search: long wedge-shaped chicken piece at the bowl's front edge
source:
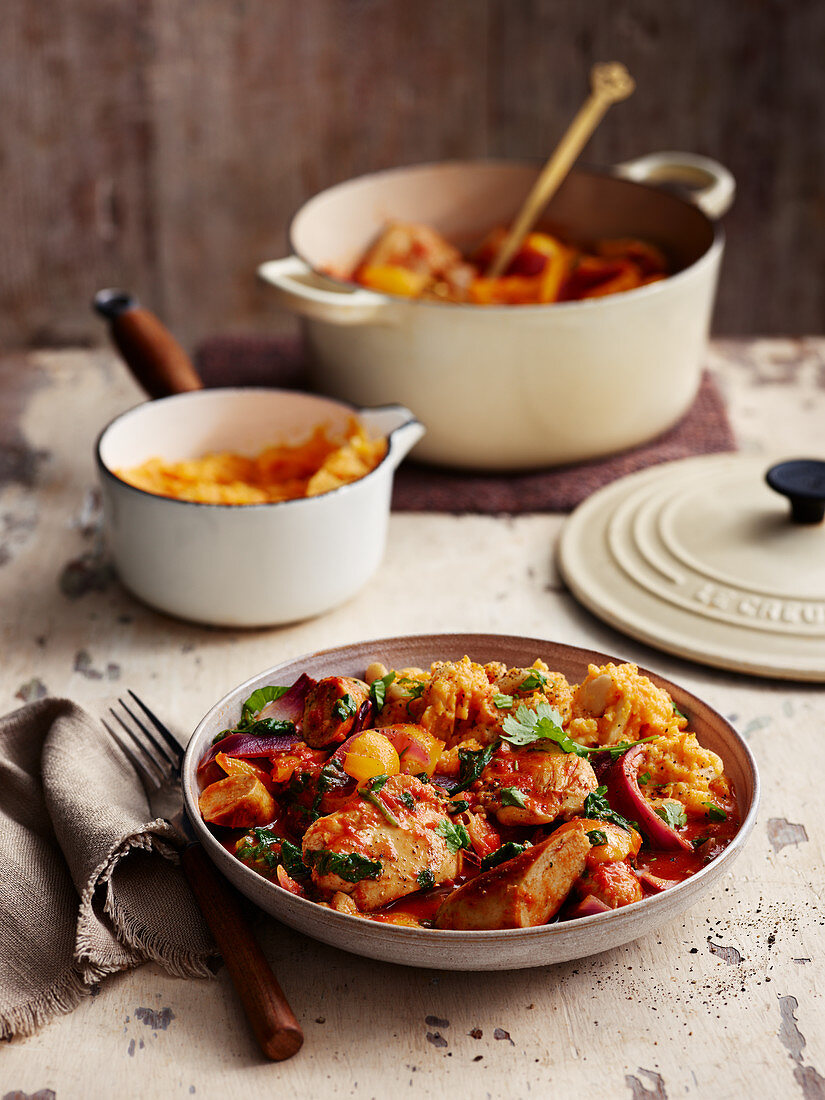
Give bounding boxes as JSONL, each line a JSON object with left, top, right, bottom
{"left": 436, "top": 831, "right": 590, "bottom": 931}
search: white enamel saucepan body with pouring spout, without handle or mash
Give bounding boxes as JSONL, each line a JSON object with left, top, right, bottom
{"left": 97, "top": 389, "right": 424, "bottom": 627}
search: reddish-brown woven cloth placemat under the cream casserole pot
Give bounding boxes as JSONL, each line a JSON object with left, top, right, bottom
{"left": 195, "top": 336, "right": 736, "bottom": 515}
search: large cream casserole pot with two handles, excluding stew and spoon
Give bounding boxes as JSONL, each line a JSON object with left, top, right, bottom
{"left": 259, "top": 153, "right": 734, "bottom": 470}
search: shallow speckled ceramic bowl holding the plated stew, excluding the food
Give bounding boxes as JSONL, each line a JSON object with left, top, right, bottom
{"left": 183, "top": 634, "right": 759, "bottom": 970}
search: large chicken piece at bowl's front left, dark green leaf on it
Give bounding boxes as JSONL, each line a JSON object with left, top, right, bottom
{"left": 304, "top": 774, "right": 459, "bottom": 912}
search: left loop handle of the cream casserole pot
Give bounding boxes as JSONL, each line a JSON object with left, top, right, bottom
{"left": 257, "top": 256, "right": 392, "bottom": 325}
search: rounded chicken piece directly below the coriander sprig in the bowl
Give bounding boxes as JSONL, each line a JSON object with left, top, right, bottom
{"left": 479, "top": 744, "right": 598, "bottom": 825}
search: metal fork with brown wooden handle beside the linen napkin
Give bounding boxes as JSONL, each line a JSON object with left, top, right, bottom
{"left": 102, "top": 691, "right": 304, "bottom": 1062}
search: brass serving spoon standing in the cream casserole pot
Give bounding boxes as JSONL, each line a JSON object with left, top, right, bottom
{"left": 487, "top": 62, "right": 636, "bottom": 278}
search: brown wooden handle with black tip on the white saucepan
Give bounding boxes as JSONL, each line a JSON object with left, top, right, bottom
{"left": 92, "top": 289, "right": 204, "bottom": 397}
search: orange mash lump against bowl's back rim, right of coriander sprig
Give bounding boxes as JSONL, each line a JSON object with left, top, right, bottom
{"left": 568, "top": 663, "right": 686, "bottom": 746}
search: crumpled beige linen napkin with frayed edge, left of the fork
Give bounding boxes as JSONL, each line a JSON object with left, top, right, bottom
{"left": 0, "top": 699, "right": 216, "bottom": 1038}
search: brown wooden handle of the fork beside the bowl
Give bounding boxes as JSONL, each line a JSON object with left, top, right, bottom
{"left": 180, "top": 844, "right": 304, "bottom": 1062}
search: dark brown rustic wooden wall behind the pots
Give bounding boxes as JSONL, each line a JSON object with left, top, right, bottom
{"left": 0, "top": 0, "right": 825, "bottom": 347}
